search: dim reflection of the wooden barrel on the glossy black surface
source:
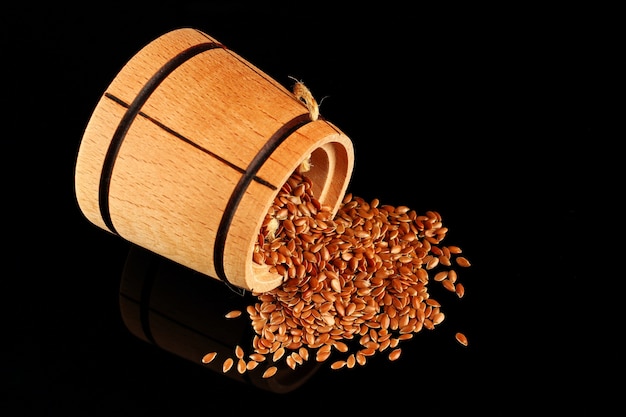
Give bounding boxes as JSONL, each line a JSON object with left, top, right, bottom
{"left": 119, "top": 245, "right": 320, "bottom": 393}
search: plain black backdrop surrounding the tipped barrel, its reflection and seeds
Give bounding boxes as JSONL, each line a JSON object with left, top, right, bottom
{"left": 0, "top": 1, "right": 624, "bottom": 416}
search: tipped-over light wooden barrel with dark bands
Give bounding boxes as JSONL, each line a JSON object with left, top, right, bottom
{"left": 75, "top": 28, "right": 354, "bottom": 292}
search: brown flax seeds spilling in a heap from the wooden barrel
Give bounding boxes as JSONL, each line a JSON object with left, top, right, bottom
{"left": 202, "top": 161, "right": 470, "bottom": 378}
